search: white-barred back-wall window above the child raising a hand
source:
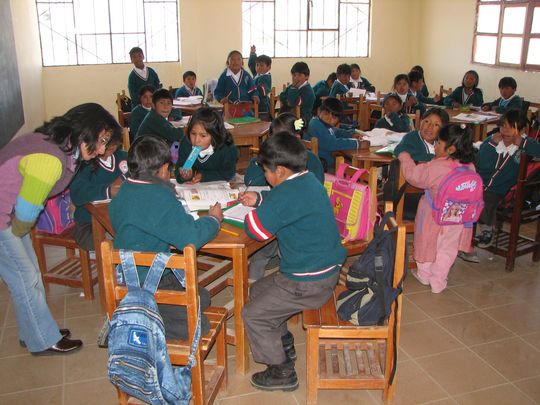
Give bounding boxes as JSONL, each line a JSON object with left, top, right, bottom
{"left": 242, "top": 0, "right": 371, "bottom": 57}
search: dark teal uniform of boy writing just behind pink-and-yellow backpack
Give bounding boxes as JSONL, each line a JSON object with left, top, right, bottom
{"left": 305, "top": 117, "right": 358, "bottom": 171}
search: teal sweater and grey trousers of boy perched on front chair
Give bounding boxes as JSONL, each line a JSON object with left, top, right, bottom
{"left": 242, "top": 171, "right": 347, "bottom": 365}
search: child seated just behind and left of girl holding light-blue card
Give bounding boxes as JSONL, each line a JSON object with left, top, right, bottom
{"left": 135, "top": 89, "right": 184, "bottom": 144}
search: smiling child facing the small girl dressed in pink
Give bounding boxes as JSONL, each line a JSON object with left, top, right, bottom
{"left": 394, "top": 108, "right": 449, "bottom": 162}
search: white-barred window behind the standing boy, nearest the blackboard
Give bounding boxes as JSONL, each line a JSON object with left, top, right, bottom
{"left": 36, "top": 0, "right": 179, "bottom": 66}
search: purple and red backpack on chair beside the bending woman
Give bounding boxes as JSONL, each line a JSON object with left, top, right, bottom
{"left": 36, "top": 189, "right": 75, "bottom": 235}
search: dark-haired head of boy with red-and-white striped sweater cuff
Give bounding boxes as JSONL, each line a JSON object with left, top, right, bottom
{"left": 257, "top": 132, "right": 307, "bottom": 187}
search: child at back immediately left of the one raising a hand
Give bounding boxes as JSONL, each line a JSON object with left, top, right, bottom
{"left": 214, "top": 51, "right": 260, "bottom": 109}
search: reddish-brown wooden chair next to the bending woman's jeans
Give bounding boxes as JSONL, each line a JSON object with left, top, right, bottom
{"left": 31, "top": 228, "right": 98, "bottom": 300}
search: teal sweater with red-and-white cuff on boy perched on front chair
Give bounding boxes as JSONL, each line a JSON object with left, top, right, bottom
{"left": 245, "top": 172, "right": 347, "bottom": 281}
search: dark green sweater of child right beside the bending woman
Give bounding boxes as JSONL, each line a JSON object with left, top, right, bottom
{"left": 69, "top": 150, "right": 128, "bottom": 224}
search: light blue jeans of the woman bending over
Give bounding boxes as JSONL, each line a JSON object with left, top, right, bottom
{"left": 0, "top": 227, "right": 62, "bottom": 352}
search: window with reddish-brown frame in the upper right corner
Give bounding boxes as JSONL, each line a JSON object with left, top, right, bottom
{"left": 473, "top": 0, "right": 540, "bottom": 70}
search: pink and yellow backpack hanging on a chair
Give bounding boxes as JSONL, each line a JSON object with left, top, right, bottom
{"left": 324, "top": 163, "right": 374, "bottom": 241}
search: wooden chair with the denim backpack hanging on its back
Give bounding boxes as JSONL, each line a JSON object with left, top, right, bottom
{"left": 101, "top": 241, "right": 227, "bottom": 405}
